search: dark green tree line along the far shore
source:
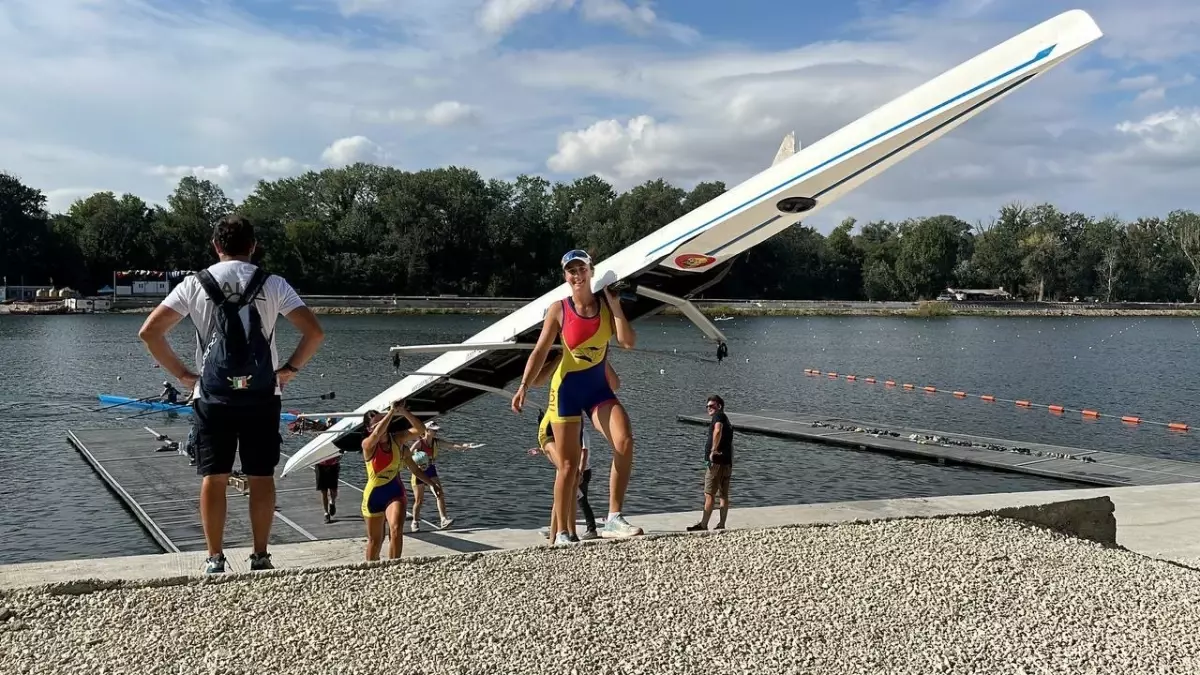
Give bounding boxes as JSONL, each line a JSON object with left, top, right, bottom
{"left": 0, "top": 163, "right": 1200, "bottom": 301}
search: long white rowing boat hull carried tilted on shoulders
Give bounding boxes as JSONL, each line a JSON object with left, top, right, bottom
{"left": 282, "top": 10, "right": 1103, "bottom": 476}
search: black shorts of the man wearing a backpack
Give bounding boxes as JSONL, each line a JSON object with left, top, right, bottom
{"left": 192, "top": 396, "right": 283, "bottom": 476}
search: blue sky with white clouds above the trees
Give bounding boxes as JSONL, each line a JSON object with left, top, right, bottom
{"left": 0, "top": 0, "right": 1200, "bottom": 232}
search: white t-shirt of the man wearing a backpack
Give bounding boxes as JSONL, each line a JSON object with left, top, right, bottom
{"left": 162, "top": 261, "right": 304, "bottom": 396}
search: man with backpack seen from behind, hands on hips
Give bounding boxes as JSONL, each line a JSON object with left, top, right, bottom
{"left": 138, "top": 215, "right": 324, "bottom": 574}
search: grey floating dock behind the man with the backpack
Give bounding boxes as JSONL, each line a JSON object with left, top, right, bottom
{"left": 67, "top": 425, "right": 366, "bottom": 552}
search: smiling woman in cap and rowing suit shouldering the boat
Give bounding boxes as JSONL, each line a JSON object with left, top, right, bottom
{"left": 512, "top": 250, "right": 642, "bottom": 543}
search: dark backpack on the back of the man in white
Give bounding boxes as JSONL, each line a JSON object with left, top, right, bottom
{"left": 196, "top": 268, "right": 276, "bottom": 405}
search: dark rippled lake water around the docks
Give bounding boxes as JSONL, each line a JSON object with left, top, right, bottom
{"left": 0, "top": 315, "right": 1200, "bottom": 563}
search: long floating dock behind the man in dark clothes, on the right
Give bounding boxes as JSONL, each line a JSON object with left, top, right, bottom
{"left": 677, "top": 411, "right": 1200, "bottom": 488}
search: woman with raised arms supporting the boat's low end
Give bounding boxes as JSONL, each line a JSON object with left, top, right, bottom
{"left": 362, "top": 401, "right": 430, "bottom": 561}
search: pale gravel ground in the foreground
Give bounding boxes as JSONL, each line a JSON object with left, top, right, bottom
{"left": 0, "top": 518, "right": 1200, "bottom": 675}
